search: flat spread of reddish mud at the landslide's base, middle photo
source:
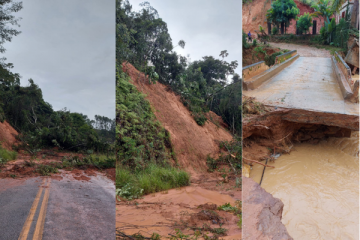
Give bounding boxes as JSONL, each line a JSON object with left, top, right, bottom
{"left": 116, "top": 186, "right": 241, "bottom": 239}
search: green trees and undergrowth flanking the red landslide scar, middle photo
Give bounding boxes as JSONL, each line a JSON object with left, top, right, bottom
{"left": 116, "top": 0, "right": 241, "bottom": 199}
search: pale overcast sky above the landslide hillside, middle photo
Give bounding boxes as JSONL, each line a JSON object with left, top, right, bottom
{"left": 129, "top": 0, "right": 242, "bottom": 76}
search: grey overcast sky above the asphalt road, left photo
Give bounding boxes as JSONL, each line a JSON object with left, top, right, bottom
{"left": 0, "top": 0, "right": 115, "bottom": 119}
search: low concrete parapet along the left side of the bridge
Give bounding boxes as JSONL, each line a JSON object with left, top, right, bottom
{"left": 243, "top": 50, "right": 300, "bottom": 90}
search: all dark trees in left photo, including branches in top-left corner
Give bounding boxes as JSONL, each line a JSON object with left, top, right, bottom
{"left": 0, "top": 0, "right": 115, "bottom": 157}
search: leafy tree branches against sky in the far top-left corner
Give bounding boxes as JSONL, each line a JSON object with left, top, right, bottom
{"left": 0, "top": 0, "right": 22, "bottom": 68}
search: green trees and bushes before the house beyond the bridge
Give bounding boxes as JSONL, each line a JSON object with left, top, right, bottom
{"left": 262, "top": 0, "right": 359, "bottom": 54}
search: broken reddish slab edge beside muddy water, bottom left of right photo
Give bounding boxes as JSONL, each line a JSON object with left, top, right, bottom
{"left": 242, "top": 177, "right": 293, "bottom": 240}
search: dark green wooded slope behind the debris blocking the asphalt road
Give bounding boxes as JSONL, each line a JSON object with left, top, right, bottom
{"left": 0, "top": 69, "right": 109, "bottom": 154}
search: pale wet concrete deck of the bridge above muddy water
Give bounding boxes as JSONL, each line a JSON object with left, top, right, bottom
{"left": 244, "top": 57, "right": 359, "bottom": 115}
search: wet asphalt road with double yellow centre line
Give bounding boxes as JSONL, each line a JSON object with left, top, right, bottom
{"left": 0, "top": 174, "right": 115, "bottom": 240}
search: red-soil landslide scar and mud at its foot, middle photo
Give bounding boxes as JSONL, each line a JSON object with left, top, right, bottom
{"left": 116, "top": 64, "right": 241, "bottom": 239}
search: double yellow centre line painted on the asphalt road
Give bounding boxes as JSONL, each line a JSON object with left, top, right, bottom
{"left": 18, "top": 178, "right": 51, "bottom": 240}
